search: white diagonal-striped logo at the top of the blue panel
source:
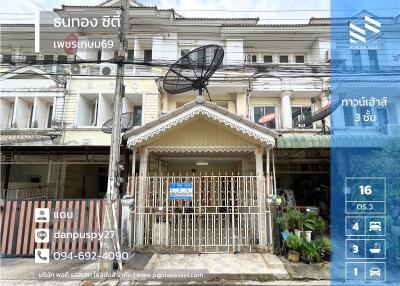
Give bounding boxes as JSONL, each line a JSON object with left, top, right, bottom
{"left": 350, "top": 16, "right": 381, "bottom": 44}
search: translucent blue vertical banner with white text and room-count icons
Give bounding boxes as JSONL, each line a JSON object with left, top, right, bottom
{"left": 330, "top": 0, "right": 400, "bottom": 285}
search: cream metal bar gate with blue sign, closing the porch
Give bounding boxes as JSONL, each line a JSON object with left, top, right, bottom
{"left": 132, "top": 176, "right": 271, "bottom": 253}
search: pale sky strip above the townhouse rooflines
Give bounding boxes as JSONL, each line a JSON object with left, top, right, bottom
{"left": 2, "top": 0, "right": 330, "bottom": 23}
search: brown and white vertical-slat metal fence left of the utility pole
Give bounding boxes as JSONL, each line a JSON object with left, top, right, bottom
{"left": 0, "top": 199, "right": 120, "bottom": 257}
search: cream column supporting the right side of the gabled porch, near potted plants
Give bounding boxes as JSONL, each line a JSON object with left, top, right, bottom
{"left": 255, "top": 147, "right": 267, "bottom": 249}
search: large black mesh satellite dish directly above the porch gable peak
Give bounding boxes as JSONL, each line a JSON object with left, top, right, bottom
{"left": 163, "top": 45, "right": 224, "bottom": 96}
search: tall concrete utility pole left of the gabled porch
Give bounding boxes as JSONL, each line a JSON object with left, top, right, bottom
{"left": 98, "top": 0, "right": 129, "bottom": 273}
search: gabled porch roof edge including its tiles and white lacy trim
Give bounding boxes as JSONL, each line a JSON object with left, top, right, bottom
{"left": 124, "top": 102, "right": 278, "bottom": 149}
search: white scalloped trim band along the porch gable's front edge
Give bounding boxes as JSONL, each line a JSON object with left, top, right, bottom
{"left": 128, "top": 104, "right": 275, "bottom": 146}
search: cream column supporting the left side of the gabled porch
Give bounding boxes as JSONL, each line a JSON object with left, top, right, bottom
{"left": 136, "top": 148, "right": 149, "bottom": 245}
